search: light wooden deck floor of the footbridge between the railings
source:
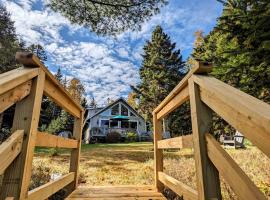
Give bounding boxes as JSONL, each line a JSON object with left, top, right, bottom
{"left": 67, "top": 186, "right": 166, "bottom": 200}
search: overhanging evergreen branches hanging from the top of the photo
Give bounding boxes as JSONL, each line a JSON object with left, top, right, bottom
{"left": 48, "top": 0, "right": 167, "bottom": 35}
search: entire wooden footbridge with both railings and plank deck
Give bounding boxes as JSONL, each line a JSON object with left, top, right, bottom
{"left": 0, "top": 53, "right": 270, "bottom": 200}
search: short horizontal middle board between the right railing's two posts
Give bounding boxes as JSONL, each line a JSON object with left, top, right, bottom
{"left": 158, "top": 135, "right": 193, "bottom": 149}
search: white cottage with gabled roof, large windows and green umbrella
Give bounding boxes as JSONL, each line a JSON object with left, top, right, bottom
{"left": 84, "top": 98, "right": 147, "bottom": 143}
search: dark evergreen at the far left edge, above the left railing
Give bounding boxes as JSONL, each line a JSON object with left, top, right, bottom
{"left": 0, "top": 4, "right": 21, "bottom": 73}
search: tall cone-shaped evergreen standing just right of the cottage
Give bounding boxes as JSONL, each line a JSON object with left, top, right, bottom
{"left": 132, "top": 26, "right": 188, "bottom": 134}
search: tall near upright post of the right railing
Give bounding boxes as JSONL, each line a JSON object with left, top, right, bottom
{"left": 188, "top": 77, "right": 222, "bottom": 200}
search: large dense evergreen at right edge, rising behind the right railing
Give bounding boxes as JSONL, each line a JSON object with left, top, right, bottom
{"left": 193, "top": 0, "right": 270, "bottom": 103}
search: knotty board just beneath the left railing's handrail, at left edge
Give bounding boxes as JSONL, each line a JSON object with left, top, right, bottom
{"left": 0, "top": 80, "right": 32, "bottom": 113}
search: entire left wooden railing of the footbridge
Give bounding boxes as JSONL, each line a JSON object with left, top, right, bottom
{"left": 0, "top": 53, "right": 84, "bottom": 200}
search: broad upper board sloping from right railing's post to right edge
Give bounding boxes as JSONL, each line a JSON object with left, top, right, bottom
{"left": 194, "top": 75, "right": 270, "bottom": 157}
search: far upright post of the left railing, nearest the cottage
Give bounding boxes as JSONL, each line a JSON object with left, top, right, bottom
{"left": 67, "top": 112, "right": 84, "bottom": 193}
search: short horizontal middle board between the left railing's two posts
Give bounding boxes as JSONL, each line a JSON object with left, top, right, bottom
{"left": 36, "top": 132, "right": 79, "bottom": 149}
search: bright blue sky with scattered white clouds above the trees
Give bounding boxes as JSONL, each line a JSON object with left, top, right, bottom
{"left": 0, "top": 0, "right": 222, "bottom": 104}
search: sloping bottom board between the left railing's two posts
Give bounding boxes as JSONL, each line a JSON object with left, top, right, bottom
{"left": 27, "top": 172, "right": 75, "bottom": 200}
